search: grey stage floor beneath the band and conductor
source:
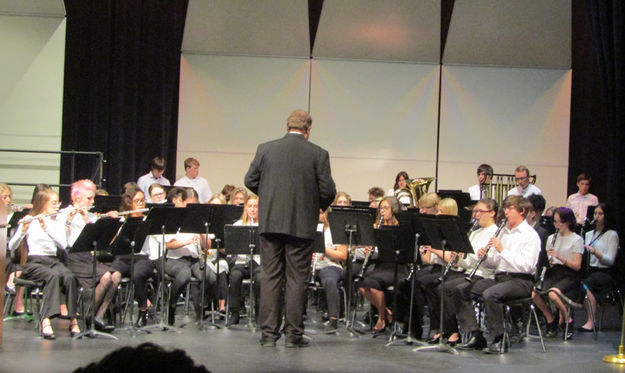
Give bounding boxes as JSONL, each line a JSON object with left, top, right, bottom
{"left": 0, "top": 308, "right": 625, "bottom": 373}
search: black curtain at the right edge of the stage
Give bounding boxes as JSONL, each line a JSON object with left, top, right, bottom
{"left": 568, "top": 0, "right": 625, "bottom": 237}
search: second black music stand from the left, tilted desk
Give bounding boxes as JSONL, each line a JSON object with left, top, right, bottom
{"left": 111, "top": 217, "right": 150, "bottom": 335}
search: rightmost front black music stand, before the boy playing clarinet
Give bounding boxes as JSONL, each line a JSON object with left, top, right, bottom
{"left": 413, "top": 215, "right": 474, "bottom": 355}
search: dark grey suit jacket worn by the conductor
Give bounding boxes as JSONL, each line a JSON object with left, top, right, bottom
{"left": 245, "top": 133, "right": 336, "bottom": 239}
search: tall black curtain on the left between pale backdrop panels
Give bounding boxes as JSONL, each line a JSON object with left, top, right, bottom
{"left": 61, "top": 0, "right": 188, "bottom": 198}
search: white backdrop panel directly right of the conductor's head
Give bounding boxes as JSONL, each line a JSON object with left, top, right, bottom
{"left": 310, "top": 60, "right": 438, "bottom": 199}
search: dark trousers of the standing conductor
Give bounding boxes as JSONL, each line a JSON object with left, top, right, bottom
{"left": 259, "top": 234, "right": 314, "bottom": 342}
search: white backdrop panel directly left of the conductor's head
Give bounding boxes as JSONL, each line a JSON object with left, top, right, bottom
{"left": 176, "top": 54, "right": 310, "bottom": 191}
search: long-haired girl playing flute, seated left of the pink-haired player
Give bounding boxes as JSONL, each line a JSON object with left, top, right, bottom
{"left": 9, "top": 189, "right": 80, "bottom": 339}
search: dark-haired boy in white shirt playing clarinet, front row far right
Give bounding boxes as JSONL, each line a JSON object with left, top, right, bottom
{"left": 458, "top": 196, "right": 540, "bottom": 354}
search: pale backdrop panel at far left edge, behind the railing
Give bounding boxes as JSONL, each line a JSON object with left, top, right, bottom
{"left": 0, "top": 16, "right": 65, "bottom": 203}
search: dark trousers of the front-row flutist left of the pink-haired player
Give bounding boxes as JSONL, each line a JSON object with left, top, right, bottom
{"left": 22, "top": 255, "right": 78, "bottom": 318}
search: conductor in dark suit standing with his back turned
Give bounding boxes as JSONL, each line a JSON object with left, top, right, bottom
{"left": 245, "top": 110, "right": 336, "bottom": 347}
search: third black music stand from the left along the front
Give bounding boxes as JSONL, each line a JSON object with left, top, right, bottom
{"left": 145, "top": 207, "right": 189, "bottom": 333}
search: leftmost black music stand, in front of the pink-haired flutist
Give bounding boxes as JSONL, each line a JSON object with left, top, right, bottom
{"left": 69, "top": 218, "right": 122, "bottom": 340}
